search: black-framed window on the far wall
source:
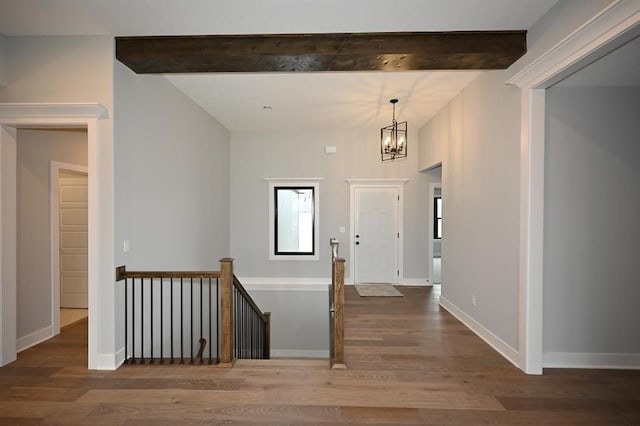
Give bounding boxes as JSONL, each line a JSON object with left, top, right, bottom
{"left": 274, "top": 187, "right": 314, "bottom": 254}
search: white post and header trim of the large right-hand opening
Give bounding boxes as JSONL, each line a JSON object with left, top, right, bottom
{"left": 506, "top": 0, "right": 640, "bottom": 374}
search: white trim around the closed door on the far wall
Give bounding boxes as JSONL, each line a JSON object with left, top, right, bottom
{"left": 347, "top": 178, "right": 409, "bottom": 284}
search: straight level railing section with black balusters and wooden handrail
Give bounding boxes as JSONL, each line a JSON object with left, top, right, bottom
{"left": 118, "top": 267, "right": 220, "bottom": 364}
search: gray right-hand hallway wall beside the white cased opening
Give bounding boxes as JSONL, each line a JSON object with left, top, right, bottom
{"left": 421, "top": 71, "right": 520, "bottom": 349}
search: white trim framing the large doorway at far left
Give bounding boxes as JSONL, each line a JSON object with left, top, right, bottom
{"left": 0, "top": 103, "right": 107, "bottom": 369}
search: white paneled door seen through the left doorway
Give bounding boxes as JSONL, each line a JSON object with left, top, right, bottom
{"left": 58, "top": 171, "right": 88, "bottom": 309}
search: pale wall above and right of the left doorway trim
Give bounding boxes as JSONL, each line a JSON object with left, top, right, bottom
{"left": 0, "top": 36, "right": 115, "bottom": 364}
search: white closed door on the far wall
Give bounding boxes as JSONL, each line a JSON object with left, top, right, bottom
{"left": 353, "top": 187, "right": 399, "bottom": 283}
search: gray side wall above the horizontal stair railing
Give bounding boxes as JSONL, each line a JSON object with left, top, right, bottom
{"left": 114, "top": 62, "right": 230, "bottom": 270}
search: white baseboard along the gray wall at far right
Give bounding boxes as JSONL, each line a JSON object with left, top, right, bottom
{"left": 542, "top": 352, "right": 640, "bottom": 370}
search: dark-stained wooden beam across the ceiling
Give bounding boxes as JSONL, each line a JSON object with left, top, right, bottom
{"left": 116, "top": 31, "right": 527, "bottom": 74}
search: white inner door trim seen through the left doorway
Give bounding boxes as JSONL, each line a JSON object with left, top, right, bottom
{"left": 49, "top": 161, "right": 89, "bottom": 336}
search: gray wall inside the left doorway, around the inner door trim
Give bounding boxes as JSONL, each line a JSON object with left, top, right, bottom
{"left": 17, "top": 129, "right": 87, "bottom": 339}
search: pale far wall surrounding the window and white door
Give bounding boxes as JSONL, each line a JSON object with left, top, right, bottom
{"left": 231, "top": 127, "right": 435, "bottom": 282}
